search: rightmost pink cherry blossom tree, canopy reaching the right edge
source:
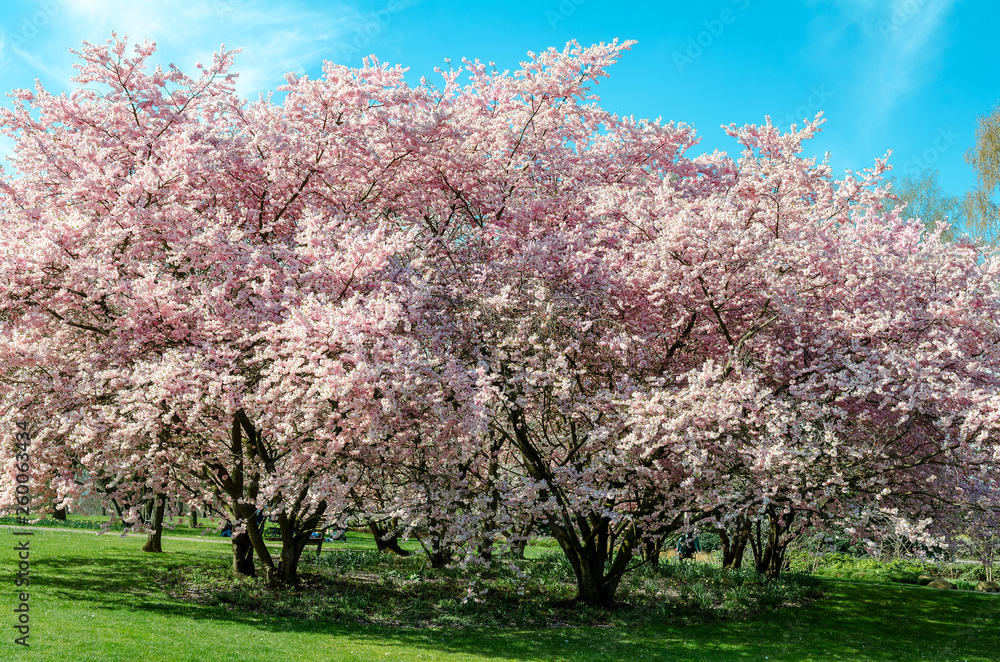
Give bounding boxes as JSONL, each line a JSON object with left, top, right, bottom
{"left": 616, "top": 123, "right": 1000, "bottom": 576}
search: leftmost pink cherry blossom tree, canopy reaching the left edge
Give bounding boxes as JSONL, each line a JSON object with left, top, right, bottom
{"left": 0, "top": 38, "right": 356, "bottom": 580}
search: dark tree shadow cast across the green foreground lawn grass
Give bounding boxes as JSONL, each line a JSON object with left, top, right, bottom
{"left": 27, "top": 552, "right": 1000, "bottom": 661}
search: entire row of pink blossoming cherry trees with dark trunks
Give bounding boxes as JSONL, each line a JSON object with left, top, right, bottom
{"left": 0, "top": 37, "right": 1000, "bottom": 604}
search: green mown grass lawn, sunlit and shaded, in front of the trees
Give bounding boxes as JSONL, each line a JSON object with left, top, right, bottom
{"left": 0, "top": 528, "right": 1000, "bottom": 662}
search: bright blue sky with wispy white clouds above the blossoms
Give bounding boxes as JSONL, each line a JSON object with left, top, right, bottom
{"left": 0, "top": 0, "right": 1000, "bottom": 202}
